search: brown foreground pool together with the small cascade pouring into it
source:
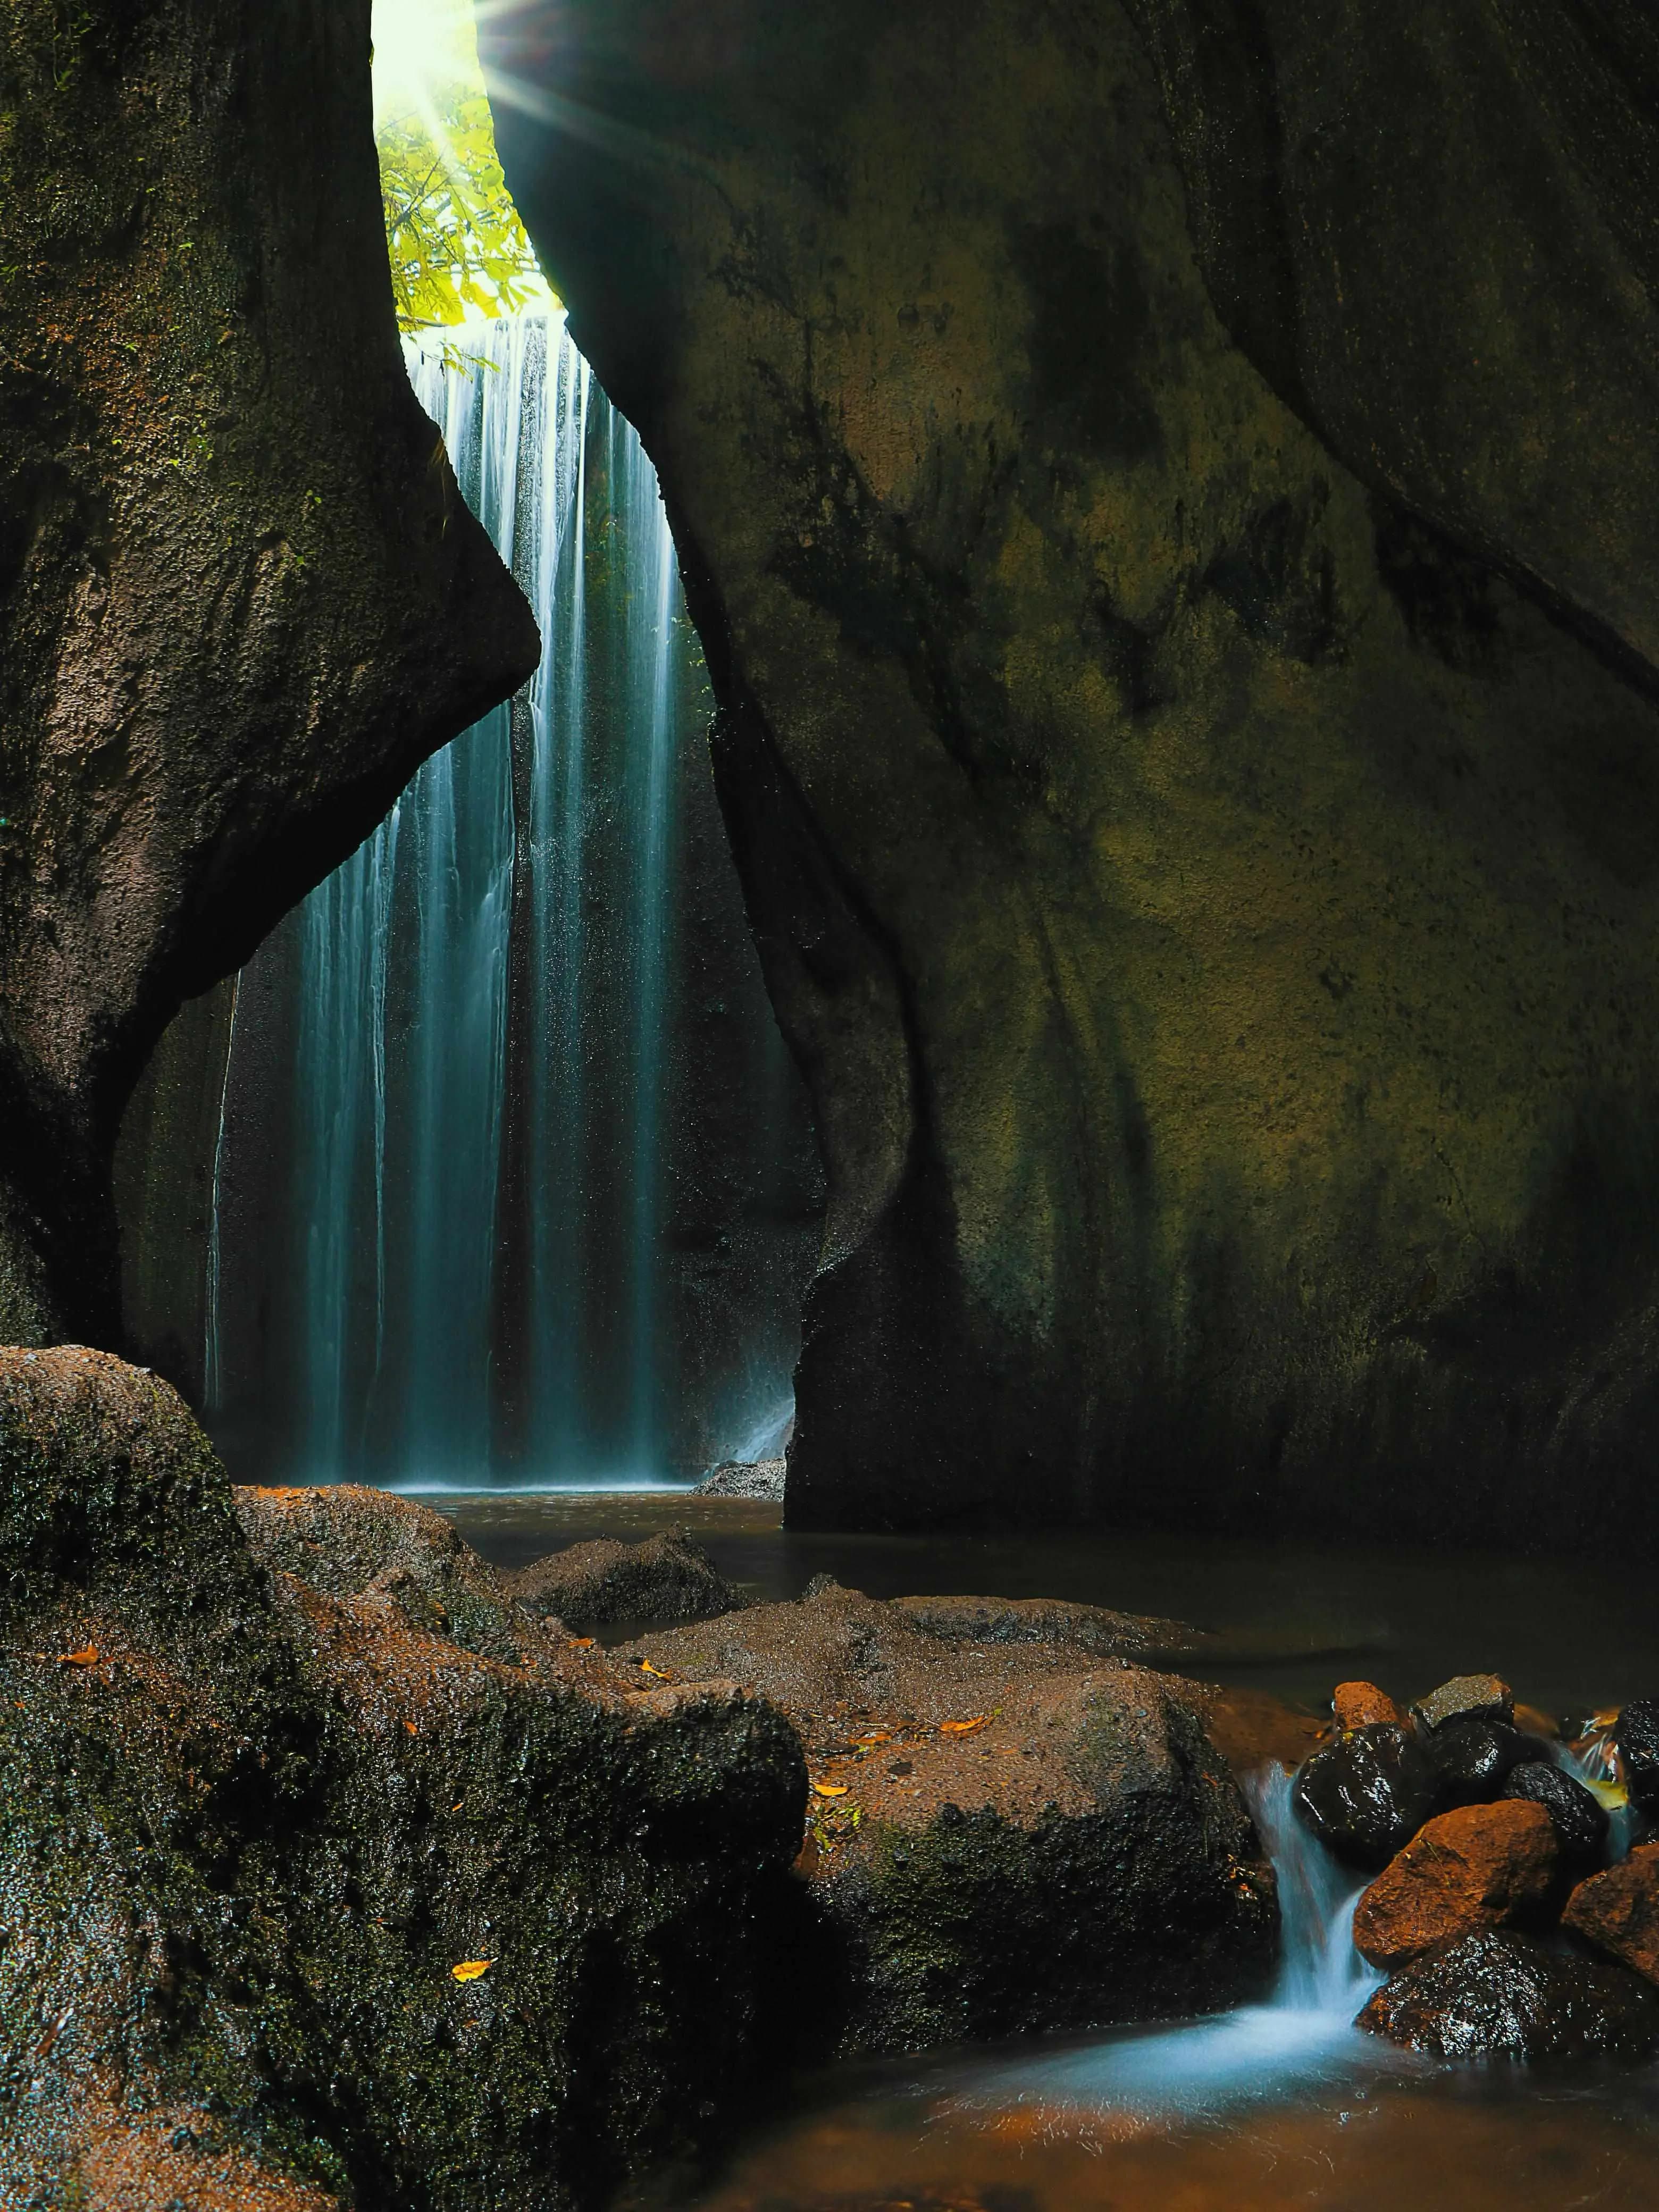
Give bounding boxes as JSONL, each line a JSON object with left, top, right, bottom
{"left": 681, "top": 1772, "right": 1659, "bottom": 2212}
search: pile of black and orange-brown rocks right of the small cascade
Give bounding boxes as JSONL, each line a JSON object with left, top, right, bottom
{"left": 1294, "top": 1674, "right": 1659, "bottom": 2059}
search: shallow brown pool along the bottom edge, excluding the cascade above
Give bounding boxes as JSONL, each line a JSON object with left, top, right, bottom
{"left": 681, "top": 2037, "right": 1659, "bottom": 2212}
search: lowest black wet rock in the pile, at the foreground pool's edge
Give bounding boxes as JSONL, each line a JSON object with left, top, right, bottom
{"left": 1358, "top": 1931, "right": 1659, "bottom": 2059}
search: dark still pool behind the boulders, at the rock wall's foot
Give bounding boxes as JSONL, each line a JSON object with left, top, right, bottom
{"left": 431, "top": 1491, "right": 1659, "bottom": 1716}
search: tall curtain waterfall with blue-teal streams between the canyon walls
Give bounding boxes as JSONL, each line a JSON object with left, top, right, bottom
{"left": 206, "top": 312, "right": 810, "bottom": 1487}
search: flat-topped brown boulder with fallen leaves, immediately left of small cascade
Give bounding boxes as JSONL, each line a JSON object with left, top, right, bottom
{"left": 613, "top": 1584, "right": 1276, "bottom": 2052}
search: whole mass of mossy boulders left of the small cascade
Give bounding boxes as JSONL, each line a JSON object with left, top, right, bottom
{"left": 0, "top": 1347, "right": 1276, "bottom": 2212}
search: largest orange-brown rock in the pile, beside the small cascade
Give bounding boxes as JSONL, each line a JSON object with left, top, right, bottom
{"left": 1354, "top": 1800, "right": 1560, "bottom": 1966}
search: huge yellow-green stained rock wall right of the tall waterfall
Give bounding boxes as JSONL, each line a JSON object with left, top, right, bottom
{"left": 482, "top": 0, "right": 1659, "bottom": 1548}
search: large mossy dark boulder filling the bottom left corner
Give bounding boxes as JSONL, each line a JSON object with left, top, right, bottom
{"left": 0, "top": 1350, "right": 805, "bottom": 2212}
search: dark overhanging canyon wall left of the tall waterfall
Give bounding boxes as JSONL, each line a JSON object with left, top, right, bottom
{"left": 0, "top": 0, "right": 535, "bottom": 1343}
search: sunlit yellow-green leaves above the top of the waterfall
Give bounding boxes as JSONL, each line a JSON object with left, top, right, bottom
{"left": 376, "top": 84, "right": 551, "bottom": 361}
